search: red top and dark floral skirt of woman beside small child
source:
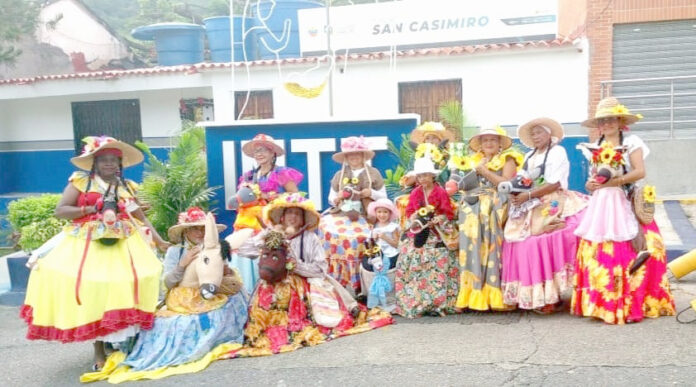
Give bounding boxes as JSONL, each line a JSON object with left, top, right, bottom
{"left": 394, "top": 184, "right": 459, "bottom": 318}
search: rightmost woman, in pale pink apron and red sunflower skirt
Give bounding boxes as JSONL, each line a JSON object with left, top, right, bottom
{"left": 571, "top": 97, "right": 675, "bottom": 324}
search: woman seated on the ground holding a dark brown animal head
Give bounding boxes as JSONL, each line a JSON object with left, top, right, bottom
{"left": 238, "top": 194, "right": 392, "bottom": 356}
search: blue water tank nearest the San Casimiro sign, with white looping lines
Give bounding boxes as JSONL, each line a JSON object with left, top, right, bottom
{"left": 254, "top": 0, "right": 324, "bottom": 59}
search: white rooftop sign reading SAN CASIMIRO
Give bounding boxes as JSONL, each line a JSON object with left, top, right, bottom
{"left": 298, "top": 0, "right": 558, "bottom": 55}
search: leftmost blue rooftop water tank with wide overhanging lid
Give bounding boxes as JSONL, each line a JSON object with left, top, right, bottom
{"left": 131, "top": 23, "right": 205, "bottom": 66}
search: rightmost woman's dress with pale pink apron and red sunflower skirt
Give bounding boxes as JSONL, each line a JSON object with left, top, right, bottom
{"left": 571, "top": 135, "right": 675, "bottom": 324}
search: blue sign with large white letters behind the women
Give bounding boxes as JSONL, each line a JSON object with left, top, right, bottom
{"left": 205, "top": 114, "right": 419, "bottom": 230}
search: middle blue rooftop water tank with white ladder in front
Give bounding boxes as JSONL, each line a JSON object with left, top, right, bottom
{"left": 203, "top": 16, "right": 258, "bottom": 62}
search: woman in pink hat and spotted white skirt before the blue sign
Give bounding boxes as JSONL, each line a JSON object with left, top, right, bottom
{"left": 319, "top": 137, "right": 387, "bottom": 295}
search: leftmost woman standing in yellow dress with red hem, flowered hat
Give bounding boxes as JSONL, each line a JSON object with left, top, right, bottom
{"left": 21, "top": 136, "right": 168, "bottom": 368}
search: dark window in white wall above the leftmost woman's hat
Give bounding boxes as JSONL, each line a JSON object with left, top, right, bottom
{"left": 72, "top": 99, "right": 143, "bottom": 154}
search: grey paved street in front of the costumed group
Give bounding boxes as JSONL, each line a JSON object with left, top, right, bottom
{"left": 0, "top": 205, "right": 696, "bottom": 386}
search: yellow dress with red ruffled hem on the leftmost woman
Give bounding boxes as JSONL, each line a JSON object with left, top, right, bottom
{"left": 21, "top": 172, "right": 162, "bottom": 342}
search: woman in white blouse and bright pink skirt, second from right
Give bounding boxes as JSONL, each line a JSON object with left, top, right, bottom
{"left": 502, "top": 118, "right": 587, "bottom": 314}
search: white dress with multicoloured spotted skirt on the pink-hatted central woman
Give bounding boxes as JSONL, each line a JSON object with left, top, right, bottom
{"left": 319, "top": 165, "right": 387, "bottom": 295}
